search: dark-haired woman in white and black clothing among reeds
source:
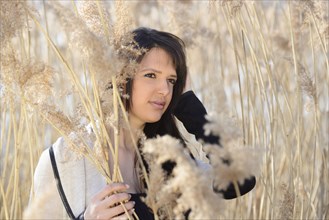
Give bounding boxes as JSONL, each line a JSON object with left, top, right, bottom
{"left": 30, "top": 28, "right": 255, "bottom": 219}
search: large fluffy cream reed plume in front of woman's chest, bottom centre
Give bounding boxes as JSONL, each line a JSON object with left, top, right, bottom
{"left": 142, "top": 135, "right": 222, "bottom": 219}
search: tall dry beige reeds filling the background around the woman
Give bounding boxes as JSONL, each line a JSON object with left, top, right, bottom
{"left": 0, "top": 1, "right": 329, "bottom": 219}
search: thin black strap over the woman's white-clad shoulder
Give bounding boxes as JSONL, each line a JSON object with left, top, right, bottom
{"left": 49, "top": 146, "right": 76, "bottom": 219}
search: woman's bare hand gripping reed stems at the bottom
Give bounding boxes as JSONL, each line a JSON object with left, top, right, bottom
{"left": 84, "top": 183, "right": 135, "bottom": 220}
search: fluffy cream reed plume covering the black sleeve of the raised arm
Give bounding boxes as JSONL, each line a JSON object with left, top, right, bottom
{"left": 204, "top": 113, "right": 262, "bottom": 191}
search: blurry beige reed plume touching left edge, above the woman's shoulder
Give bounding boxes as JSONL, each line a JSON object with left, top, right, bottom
{"left": 0, "top": 45, "right": 57, "bottom": 108}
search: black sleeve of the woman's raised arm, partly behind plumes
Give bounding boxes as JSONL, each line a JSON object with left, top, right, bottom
{"left": 174, "top": 91, "right": 256, "bottom": 199}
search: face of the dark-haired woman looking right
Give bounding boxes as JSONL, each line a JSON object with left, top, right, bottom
{"left": 129, "top": 48, "right": 177, "bottom": 128}
